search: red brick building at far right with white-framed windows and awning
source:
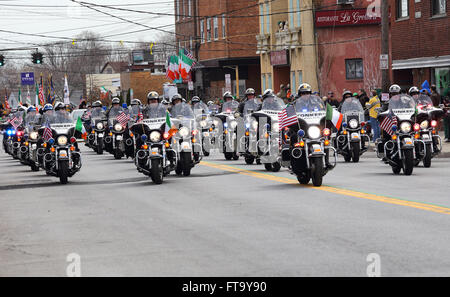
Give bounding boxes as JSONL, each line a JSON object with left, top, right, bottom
{"left": 389, "top": 0, "right": 450, "bottom": 91}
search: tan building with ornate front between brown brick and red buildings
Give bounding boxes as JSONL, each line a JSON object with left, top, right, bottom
{"left": 256, "top": 0, "right": 318, "bottom": 97}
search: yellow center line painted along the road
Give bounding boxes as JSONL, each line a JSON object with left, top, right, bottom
{"left": 200, "top": 161, "right": 450, "bottom": 214}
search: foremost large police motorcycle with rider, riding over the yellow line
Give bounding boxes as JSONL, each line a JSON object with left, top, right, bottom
{"left": 281, "top": 84, "right": 337, "bottom": 187}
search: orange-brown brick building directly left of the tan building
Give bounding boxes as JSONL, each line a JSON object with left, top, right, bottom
{"left": 175, "top": 0, "right": 261, "bottom": 98}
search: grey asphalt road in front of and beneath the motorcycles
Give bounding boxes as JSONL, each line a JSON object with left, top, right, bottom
{"left": 0, "top": 148, "right": 450, "bottom": 276}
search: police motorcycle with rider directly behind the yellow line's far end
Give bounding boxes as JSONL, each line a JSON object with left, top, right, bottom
{"left": 191, "top": 96, "right": 214, "bottom": 157}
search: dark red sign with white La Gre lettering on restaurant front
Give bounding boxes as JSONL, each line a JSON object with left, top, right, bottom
{"left": 315, "top": 8, "right": 381, "bottom": 27}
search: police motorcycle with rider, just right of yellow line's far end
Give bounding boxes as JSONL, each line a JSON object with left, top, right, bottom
{"left": 213, "top": 92, "right": 240, "bottom": 160}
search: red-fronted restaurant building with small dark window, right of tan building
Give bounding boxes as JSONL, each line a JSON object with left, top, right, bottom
{"left": 314, "top": 0, "right": 381, "bottom": 99}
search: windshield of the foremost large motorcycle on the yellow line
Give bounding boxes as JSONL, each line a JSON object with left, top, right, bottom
{"left": 294, "top": 95, "right": 326, "bottom": 124}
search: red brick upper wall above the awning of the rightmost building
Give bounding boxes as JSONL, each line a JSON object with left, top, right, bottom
{"left": 389, "top": 0, "right": 450, "bottom": 60}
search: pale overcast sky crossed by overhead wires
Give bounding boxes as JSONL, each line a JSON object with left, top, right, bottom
{"left": 0, "top": 0, "right": 175, "bottom": 52}
